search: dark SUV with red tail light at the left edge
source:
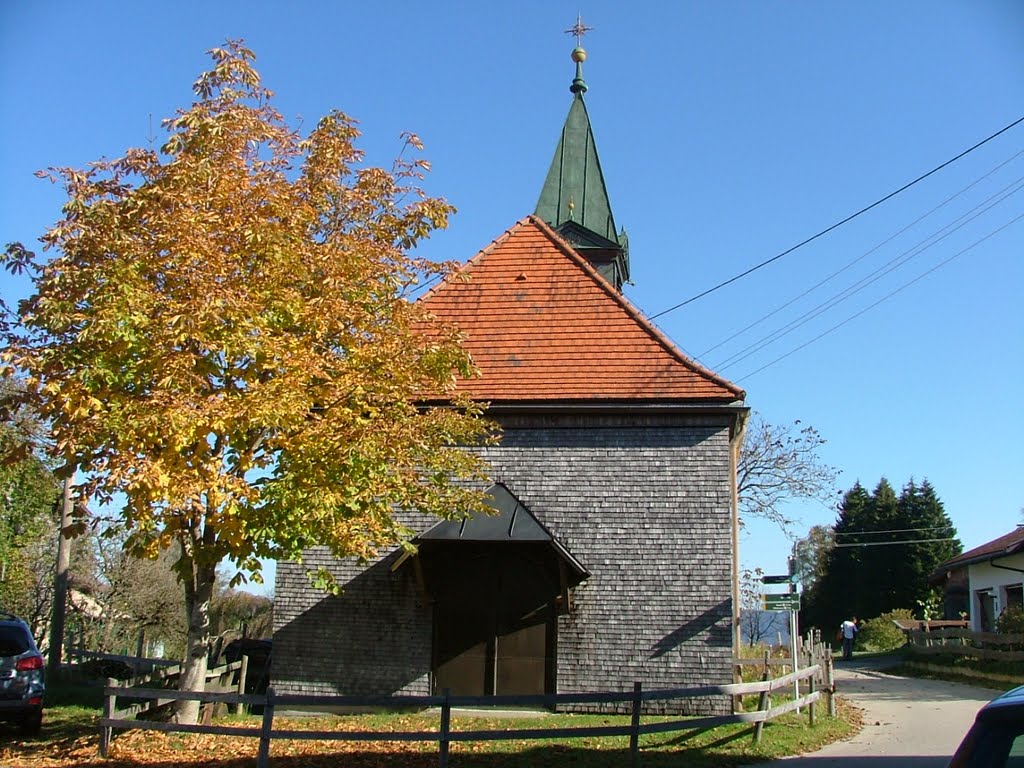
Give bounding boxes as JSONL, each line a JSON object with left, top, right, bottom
{"left": 0, "top": 611, "right": 45, "bottom": 734}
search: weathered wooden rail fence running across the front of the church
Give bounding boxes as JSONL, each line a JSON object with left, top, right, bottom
{"left": 99, "top": 666, "right": 830, "bottom": 768}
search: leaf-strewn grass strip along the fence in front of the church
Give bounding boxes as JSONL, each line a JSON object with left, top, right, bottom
{"left": 0, "top": 667, "right": 858, "bottom": 768}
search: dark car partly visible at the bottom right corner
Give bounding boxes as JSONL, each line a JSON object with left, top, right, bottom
{"left": 949, "top": 685, "right": 1024, "bottom": 768}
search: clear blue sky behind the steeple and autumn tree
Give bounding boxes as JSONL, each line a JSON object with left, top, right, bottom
{"left": 0, "top": 0, "right": 1024, "bottom": 593}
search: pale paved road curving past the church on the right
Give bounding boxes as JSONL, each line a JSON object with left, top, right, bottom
{"left": 757, "top": 659, "right": 999, "bottom": 768}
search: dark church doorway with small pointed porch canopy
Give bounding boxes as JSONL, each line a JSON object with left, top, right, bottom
{"left": 417, "top": 484, "right": 589, "bottom": 695}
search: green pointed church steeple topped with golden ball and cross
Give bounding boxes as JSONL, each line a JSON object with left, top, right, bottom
{"left": 535, "top": 18, "right": 630, "bottom": 291}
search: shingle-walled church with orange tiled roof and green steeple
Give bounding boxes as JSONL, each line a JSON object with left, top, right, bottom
{"left": 272, "top": 40, "right": 746, "bottom": 714}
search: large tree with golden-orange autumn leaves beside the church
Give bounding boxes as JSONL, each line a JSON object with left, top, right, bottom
{"left": 3, "top": 41, "right": 490, "bottom": 722}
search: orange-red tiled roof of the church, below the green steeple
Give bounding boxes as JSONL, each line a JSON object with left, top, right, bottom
{"left": 421, "top": 216, "right": 744, "bottom": 403}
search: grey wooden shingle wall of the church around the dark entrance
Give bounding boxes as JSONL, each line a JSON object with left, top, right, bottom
{"left": 273, "top": 414, "right": 732, "bottom": 714}
